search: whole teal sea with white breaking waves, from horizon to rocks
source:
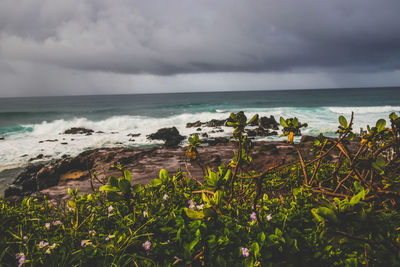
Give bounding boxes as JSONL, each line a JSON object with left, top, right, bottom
{"left": 0, "top": 87, "right": 400, "bottom": 195}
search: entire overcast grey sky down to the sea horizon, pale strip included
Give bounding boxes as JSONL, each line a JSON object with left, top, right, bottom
{"left": 0, "top": 0, "right": 400, "bottom": 97}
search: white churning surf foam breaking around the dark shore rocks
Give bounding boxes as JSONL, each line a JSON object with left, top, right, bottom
{"left": 0, "top": 106, "right": 400, "bottom": 170}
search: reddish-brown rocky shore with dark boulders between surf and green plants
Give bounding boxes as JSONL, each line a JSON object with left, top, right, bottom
{"left": 4, "top": 113, "right": 340, "bottom": 203}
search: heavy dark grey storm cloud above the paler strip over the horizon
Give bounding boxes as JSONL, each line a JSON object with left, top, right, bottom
{"left": 0, "top": 0, "right": 400, "bottom": 75}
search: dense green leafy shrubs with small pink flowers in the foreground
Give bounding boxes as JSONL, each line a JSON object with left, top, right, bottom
{"left": 0, "top": 112, "right": 400, "bottom": 266}
